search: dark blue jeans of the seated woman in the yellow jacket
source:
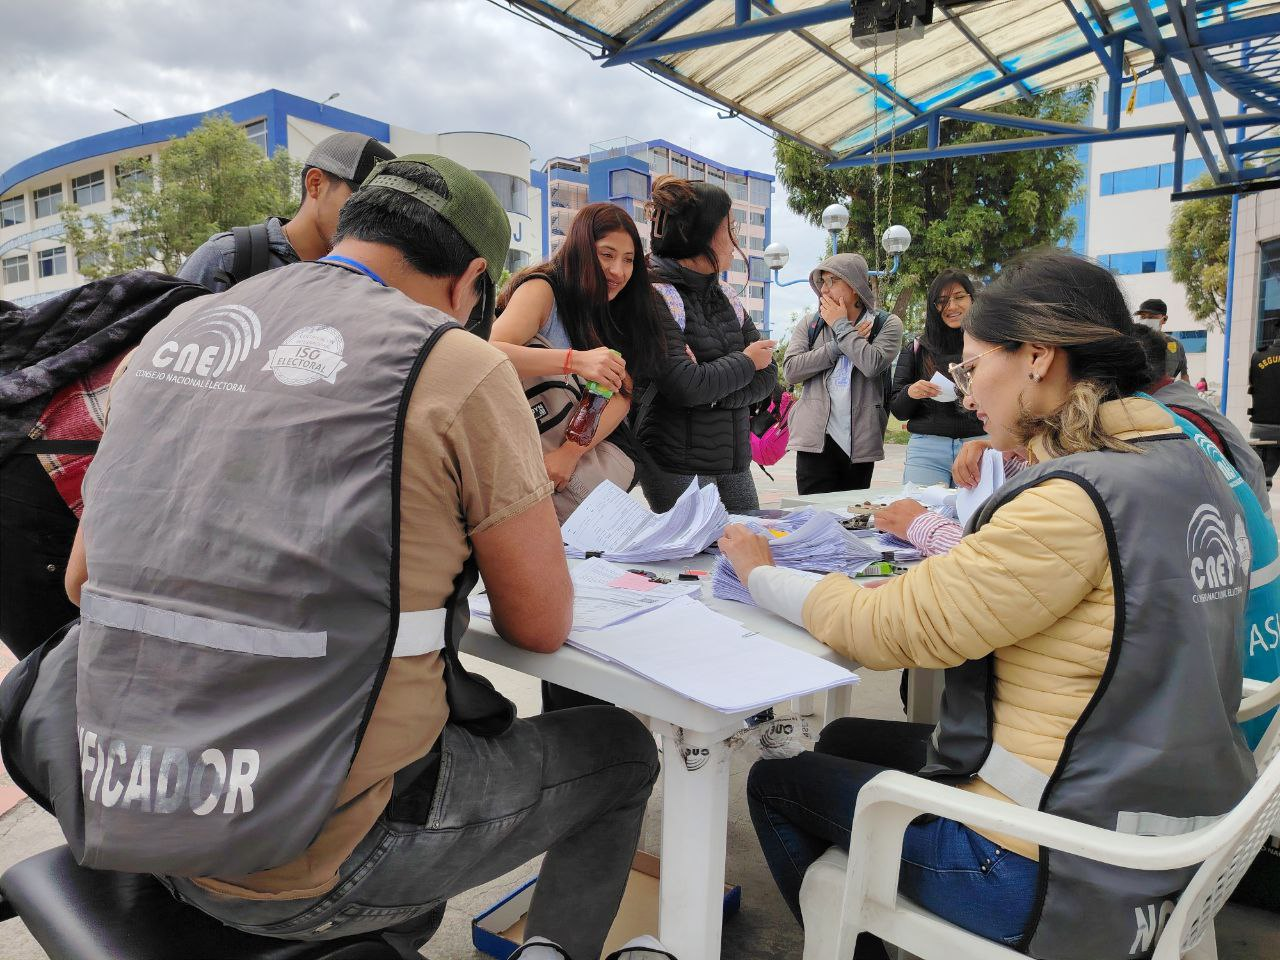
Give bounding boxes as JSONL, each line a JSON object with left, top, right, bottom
{"left": 746, "top": 719, "right": 1038, "bottom": 957}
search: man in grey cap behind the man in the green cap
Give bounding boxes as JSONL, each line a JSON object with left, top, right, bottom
{"left": 178, "top": 133, "right": 396, "bottom": 293}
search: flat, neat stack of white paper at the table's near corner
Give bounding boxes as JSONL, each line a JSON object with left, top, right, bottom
{"left": 568, "top": 598, "right": 858, "bottom": 713}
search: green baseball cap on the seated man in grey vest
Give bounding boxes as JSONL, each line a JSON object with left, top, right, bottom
{"left": 362, "top": 154, "right": 511, "bottom": 287}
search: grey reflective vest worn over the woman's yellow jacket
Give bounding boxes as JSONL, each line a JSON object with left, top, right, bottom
{"left": 920, "top": 433, "right": 1256, "bottom": 960}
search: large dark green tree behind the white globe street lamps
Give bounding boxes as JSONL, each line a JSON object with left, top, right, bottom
{"left": 774, "top": 88, "right": 1092, "bottom": 316}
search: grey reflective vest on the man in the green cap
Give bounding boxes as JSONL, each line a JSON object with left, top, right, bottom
{"left": 17, "top": 264, "right": 513, "bottom": 877}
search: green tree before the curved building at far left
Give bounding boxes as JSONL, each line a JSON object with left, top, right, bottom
{"left": 61, "top": 114, "right": 302, "bottom": 279}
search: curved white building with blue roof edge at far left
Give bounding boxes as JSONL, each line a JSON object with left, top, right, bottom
{"left": 0, "top": 90, "right": 543, "bottom": 303}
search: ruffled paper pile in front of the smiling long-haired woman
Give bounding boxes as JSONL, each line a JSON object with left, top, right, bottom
{"left": 561, "top": 480, "right": 728, "bottom": 563}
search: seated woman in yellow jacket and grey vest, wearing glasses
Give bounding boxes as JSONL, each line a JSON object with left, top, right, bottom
{"left": 721, "top": 251, "right": 1254, "bottom": 960}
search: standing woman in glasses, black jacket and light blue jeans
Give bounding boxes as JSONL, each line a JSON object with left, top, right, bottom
{"left": 890, "top": 270, "right": 984, "bottom": 486}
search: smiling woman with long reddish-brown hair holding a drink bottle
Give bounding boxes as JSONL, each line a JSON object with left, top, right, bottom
{"left": 489, "top": 204, "right": 663, "bottom": 504}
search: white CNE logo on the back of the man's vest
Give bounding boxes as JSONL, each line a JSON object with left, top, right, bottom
{"left": 138, "top": 303, "right": 262, "bottom": 393}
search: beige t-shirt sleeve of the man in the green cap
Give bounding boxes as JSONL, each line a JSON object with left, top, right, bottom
{"left": 447, "top": 360, "right": 554, "bottom": 536}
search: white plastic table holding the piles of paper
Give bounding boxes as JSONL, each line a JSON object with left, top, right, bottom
{"left": 462, "top": 554, "right": 858, "bottom": 960}
